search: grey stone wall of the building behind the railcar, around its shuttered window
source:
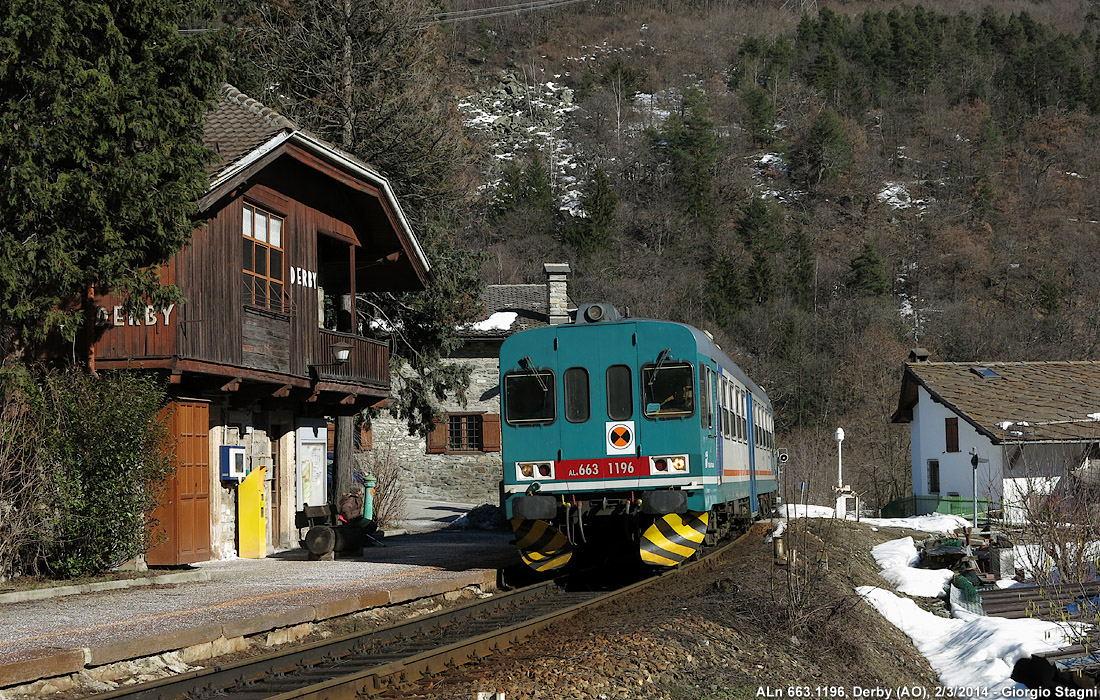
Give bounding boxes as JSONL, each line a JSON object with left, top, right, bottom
{"left": 372, "top": 353, "right": 501, "bottom": 505}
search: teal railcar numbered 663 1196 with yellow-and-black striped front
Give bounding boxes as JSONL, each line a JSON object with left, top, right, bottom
{"left": 501, "top": 304, "right": 778, "bottom": 571}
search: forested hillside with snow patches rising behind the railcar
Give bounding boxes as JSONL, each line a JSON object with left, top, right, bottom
{"left": 443, "top": 0, "right": 1100, "bottom": 505}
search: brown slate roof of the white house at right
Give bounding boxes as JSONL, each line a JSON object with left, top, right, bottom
{"left": 891, "top": 361, "right": 1100, "bottom": 444}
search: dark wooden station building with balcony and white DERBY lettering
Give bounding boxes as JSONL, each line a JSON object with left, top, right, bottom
{"left": 89, "top": 86, "right": 431, "bottom": 565}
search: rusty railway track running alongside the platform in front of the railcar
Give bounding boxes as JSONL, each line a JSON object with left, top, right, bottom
{"left": 97, "top": 532, "right": 739, "bottom": 700}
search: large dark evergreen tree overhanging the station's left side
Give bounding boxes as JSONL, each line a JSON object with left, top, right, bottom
{"left": 0, "top": 0, "right": 220, "bottom": 358}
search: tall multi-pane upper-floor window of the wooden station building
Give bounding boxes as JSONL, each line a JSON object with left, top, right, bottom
{"left": 241, "top": 205, "right": 287, "bottom": 313}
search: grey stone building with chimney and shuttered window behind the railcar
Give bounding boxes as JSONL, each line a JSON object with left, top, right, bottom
{"left": 372, "top": 263, "right": 576, "bottom": 504}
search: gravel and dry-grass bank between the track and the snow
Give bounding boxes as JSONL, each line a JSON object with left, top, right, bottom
{"left": 392, "top": 519, "right": 937, "bottom": 700}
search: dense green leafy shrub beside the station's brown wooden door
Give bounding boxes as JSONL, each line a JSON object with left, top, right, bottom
{"left": 0, "top": 370, "right": 172, "bottom": 578}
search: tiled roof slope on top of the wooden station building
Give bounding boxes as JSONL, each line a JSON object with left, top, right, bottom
{"left": 202, "top": 85, "right": 298, "bottom": 173}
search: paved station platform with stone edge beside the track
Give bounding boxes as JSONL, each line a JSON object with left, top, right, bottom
{"left": 0, "top": 502, "right": 519, "bottom": 698}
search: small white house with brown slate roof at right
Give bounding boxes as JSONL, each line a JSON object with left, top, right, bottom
{"left": 892, "top": 348, "right": 1100, "bottom": 517}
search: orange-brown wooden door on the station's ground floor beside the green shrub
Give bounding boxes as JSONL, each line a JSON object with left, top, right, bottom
{"left": 145, "top": 401, "right": 210, "bottom": 566}
